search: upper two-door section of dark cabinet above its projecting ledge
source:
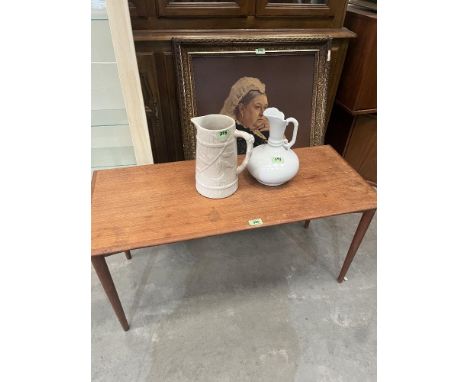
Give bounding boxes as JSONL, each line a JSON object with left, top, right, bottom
{"left": 129, "top": 0, "right": 347, "bottom": 30}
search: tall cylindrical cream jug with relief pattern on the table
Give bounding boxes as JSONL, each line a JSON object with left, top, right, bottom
{"left": 191, "top": 114, "right": 255, "bottom": 199}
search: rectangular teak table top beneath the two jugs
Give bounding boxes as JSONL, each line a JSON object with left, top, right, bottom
{"left": 91, "top": 146, "right": 377, "bottom": 256}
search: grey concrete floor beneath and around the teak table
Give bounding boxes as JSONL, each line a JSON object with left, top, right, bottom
{"left": 91, "top": 214, "right": 377, "bottom": 382}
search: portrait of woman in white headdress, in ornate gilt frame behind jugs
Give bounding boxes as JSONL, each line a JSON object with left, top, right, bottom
{"left": 173, "top": 36, "right": 331, "bottom": 159}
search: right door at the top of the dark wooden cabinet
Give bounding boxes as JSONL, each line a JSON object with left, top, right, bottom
{"left": 255, "top": 0, "right": 340, "bottom": 17}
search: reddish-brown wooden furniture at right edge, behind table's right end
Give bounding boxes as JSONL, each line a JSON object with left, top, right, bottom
{"left": 325, "top": 6, "right": 377, "bottom": 183}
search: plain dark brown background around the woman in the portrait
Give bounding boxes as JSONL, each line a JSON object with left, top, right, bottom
{"left": 192, "top": 52, "right": 315, "bottom": 147}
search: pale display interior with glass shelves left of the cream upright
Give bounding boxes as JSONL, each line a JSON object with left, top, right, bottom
{"left": 91, "top": 0, "right": 136, "bottom": 170}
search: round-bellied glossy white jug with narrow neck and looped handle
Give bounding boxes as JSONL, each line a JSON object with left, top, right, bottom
{"left": 247, "top": 107, "right": 299, "bottom": 186}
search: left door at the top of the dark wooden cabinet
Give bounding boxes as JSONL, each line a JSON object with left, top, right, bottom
{"left": 156, "top": 0, "right": 255, "bottom": 17}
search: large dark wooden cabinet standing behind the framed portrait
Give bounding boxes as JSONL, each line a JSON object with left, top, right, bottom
{"left": 129, "top": 0, "right": 355, "bottom": 163}
